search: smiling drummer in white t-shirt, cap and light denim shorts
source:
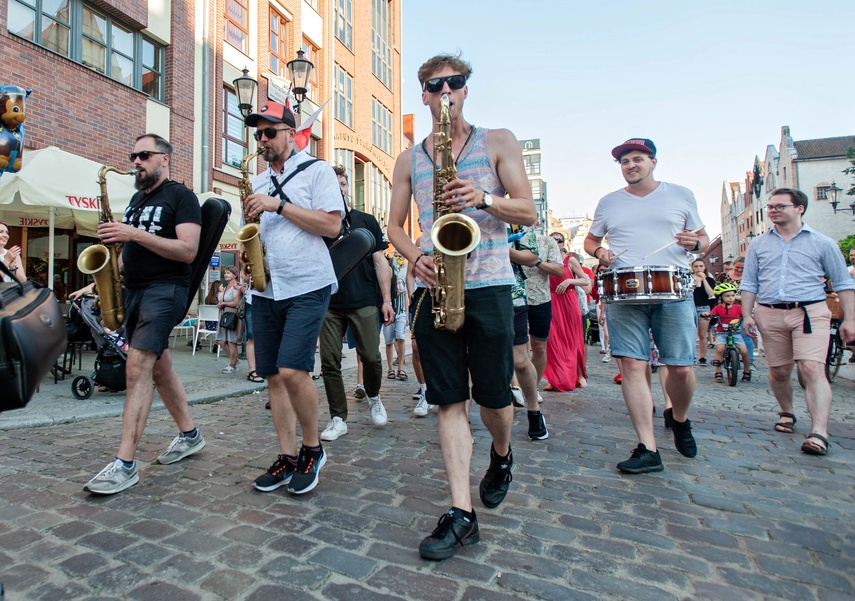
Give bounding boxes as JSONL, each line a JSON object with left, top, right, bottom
{"left": 585, "top": 138, "right": 709, "bottom": 474}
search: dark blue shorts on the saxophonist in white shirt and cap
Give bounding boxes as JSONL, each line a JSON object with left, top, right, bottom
{"left": 252, "top": 286, "right": 330, "bottom": 376}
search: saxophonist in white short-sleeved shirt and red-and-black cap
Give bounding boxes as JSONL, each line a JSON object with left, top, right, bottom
{"left": 244, "top": 101, "right": 344, "bottom": 494}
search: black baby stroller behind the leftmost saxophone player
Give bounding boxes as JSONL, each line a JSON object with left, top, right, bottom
{"left": 71, "top": 296, "right": 128, "bottom": 400}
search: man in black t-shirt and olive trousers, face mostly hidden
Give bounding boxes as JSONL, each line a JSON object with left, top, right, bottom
{"left": 320, "top": 166, "right": 395, "bottom": 441}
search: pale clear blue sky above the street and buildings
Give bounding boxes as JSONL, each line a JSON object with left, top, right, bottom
{"left": 402, "top": 0, "right": 855, "bottom": 234}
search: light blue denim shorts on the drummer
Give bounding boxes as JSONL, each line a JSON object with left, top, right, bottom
{"left": 606, "top": 298, "right": 698, "bottom": 366}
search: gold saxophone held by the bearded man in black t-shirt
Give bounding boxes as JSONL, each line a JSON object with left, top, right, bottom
{"left": 77, "top": 165, "right": 137, "bottom": 330}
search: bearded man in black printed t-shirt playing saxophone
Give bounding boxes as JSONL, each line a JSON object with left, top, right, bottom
{"left": 83, "top": 134, "right": 205, "bottom": 495}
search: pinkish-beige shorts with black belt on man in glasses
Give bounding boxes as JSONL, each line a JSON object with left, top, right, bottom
{"left": 754, "top": 303, "right": 831, "bottom": 367}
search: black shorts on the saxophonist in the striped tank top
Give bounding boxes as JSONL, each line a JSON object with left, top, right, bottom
{"left": 413, "top": 286, "right": 514, "bottom": 409}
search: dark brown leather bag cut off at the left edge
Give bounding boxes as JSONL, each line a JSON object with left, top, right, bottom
{"left": 0, "top": 261, "right": 67, "bottom": 411}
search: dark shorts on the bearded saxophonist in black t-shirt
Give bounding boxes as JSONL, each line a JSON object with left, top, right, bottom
{"left": 123, "top": 284, "right": 188, "bottom": 358}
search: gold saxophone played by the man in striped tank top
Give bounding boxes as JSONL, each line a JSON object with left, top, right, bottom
{"left": 430, "top": 94, "right": 481, "bottom": 332}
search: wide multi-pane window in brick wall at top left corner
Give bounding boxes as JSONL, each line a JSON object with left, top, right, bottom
{"left": 6, "top": 0, "right": 163, "bottom": 101}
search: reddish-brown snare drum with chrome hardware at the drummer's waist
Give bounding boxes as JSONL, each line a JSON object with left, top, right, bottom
{"left": 598, "top": 265, "right": 694, "bottom": 305}
